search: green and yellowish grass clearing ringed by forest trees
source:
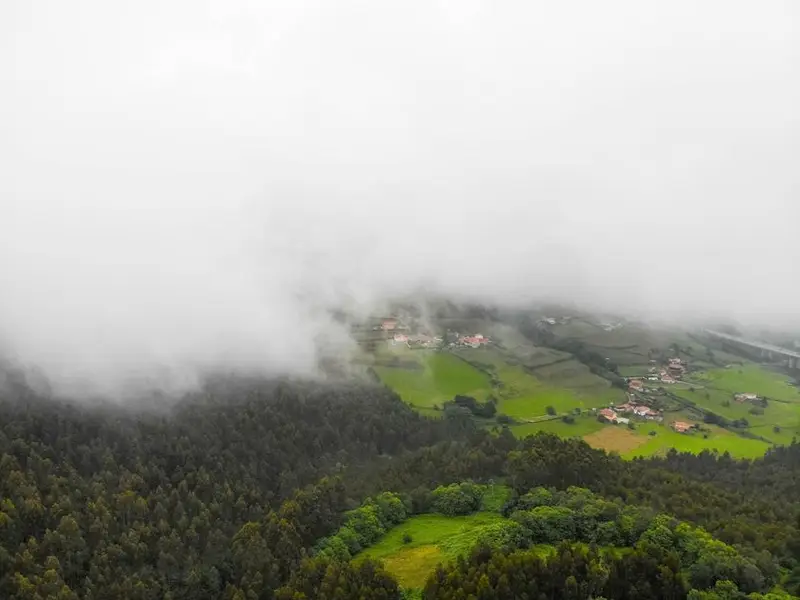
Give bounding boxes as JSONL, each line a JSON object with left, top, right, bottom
{"left": 356, "top": 512, "right": 504, "bottom": 588}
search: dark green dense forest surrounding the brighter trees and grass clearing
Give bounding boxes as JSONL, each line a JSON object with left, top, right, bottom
{"left": 0, "top": 379, "right": 800, "bottom": 600}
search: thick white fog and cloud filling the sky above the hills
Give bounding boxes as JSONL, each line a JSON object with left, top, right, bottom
{"left": 0, "top": 0, "right": 800, "bottom": 396}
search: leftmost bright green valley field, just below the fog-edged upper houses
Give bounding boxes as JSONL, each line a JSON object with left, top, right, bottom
{"left": 373, "top": 350, "right": 492, "bottom": 407}
